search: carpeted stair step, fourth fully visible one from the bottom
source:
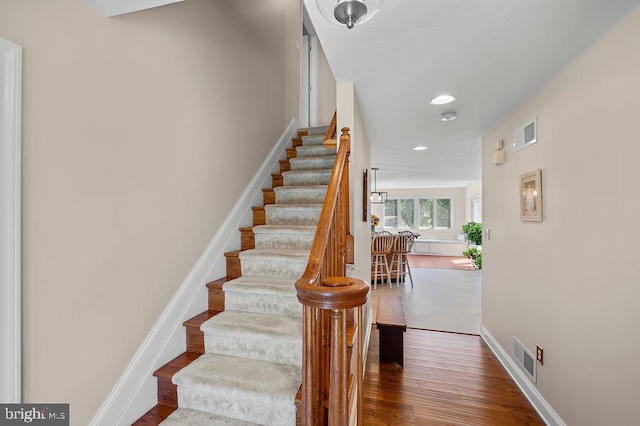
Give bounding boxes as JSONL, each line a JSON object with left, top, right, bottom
{"left": 240, "top": 249, "right": 309, "bottom": 279}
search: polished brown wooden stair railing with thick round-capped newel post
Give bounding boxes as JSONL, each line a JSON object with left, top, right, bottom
{"left": 296, "top": 125, "right": 369, "bottom": 426}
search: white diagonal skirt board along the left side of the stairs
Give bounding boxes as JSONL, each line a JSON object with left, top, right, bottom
{"left": 91, "top": 120, "right": 298, "bottom": 426}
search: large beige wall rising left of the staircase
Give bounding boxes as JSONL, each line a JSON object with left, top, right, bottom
{"left": 0, "top": 0, "right": 301, "bottom": 425}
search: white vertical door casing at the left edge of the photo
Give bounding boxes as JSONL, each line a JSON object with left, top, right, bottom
{"left": 0, "top": 38, "right": 22, "bottom": 403}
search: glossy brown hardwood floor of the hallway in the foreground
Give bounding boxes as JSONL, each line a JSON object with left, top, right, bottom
{"left": 364, "top": 326, "right": 544, "bottom": 426}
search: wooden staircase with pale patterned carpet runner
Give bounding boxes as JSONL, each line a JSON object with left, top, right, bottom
{"left": 135, "top": 123, "right": 336, "bottom": 426}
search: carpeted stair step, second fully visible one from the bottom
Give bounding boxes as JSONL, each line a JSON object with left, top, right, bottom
{"left": 200, "top": 311, "right": 302, "bottom": 366}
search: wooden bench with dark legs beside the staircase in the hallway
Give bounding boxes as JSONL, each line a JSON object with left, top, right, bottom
{"left": 376, "top": 296, "right": 407, "bottom": 366}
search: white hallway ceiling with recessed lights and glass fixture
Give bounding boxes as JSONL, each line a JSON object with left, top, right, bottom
{"left": 303, "top": 0, "right": 640, "bottom": 189}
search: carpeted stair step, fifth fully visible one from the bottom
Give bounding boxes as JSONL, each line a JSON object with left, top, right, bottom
{"left": 253, "top": 225, "right": 316, "bottom": 250}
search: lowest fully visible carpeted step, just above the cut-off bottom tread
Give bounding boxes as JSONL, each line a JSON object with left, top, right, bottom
{"left": 173, "top": 353, "right": 302, "bottom": 425}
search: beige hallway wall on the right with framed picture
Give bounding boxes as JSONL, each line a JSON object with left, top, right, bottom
{"left": 482, "top": 5, "right": 640, "bottom": 425}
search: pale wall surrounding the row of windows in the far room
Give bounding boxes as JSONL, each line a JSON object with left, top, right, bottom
{"left": 372, "top": 188, "right": 466, "bottom": 240}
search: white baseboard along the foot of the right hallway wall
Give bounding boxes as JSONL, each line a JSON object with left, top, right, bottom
{"left": 480, "top": 324, "right": 566, "bottom": 426}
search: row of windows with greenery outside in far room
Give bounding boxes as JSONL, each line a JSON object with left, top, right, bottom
{"left": 383, "top": 198, "right": 453, "bottom": 230}
